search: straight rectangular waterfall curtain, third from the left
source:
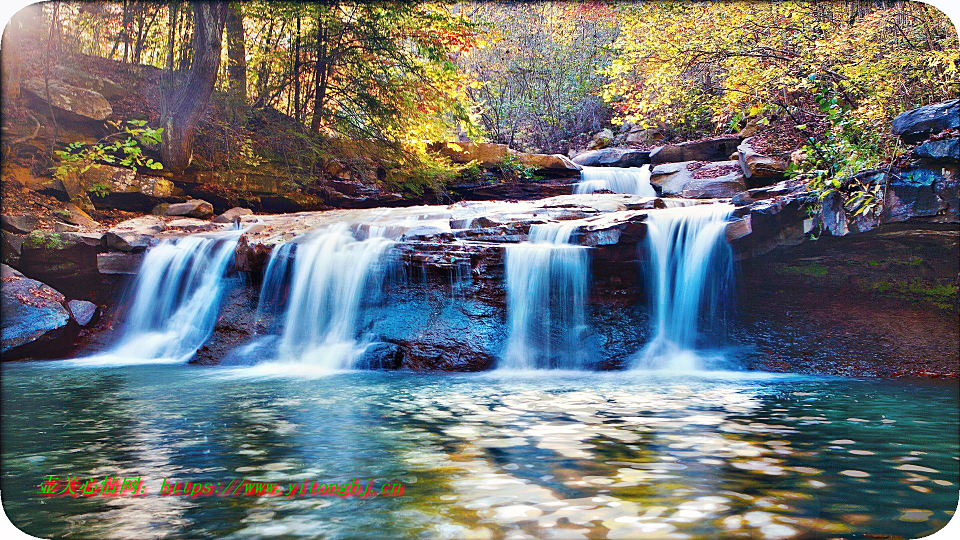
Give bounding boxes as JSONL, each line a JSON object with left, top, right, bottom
{"left": 499, "top": 224, "right": 589, "bottom": 370}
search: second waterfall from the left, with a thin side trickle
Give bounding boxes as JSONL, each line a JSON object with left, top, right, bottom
{"left": 258, "top": 223, "right": 393, "bottom": 370}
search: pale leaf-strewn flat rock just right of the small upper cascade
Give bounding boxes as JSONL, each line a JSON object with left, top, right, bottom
{"left": 650, "top": 161, "right": 747, "bottom": 199}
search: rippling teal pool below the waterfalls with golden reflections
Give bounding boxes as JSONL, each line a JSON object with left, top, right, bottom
{"left": 2, "top": 362, "right": 960, "bottom": 538}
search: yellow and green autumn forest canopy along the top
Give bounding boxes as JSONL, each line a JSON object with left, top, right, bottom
{"left": 5, "top": 0, "right": 958, "bottom": 181}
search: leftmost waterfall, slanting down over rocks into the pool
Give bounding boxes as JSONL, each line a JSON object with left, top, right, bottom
{"left": 90, "top": 231, "right": 241, "bottom": 363}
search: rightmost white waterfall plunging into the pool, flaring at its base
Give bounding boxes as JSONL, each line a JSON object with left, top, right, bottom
{"left": 635, "top": 204, "right": 734, "bottom": 371}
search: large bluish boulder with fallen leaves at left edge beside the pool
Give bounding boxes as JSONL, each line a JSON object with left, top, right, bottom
{"left": 0, "top": 264, "right": 70, "bottom": 360}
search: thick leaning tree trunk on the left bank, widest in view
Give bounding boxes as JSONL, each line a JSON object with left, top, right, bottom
{"left": 160, "top": 1, "right": 227, "bottom": 173}
